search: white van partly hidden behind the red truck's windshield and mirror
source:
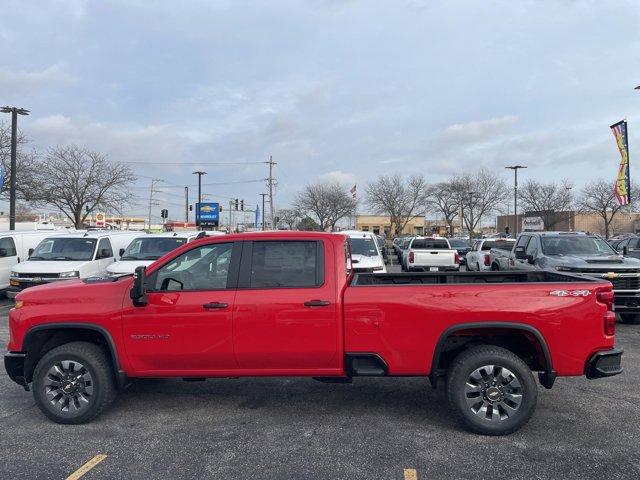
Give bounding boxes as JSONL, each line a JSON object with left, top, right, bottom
{"left": 107, "top": 230, "right": 210, "bottom": 277}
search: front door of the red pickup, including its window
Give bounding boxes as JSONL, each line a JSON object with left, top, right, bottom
{"left": 123, "top": 242, "right": 241, "bottom": 376}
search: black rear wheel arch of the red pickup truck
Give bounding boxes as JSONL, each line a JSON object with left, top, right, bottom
{"left": 429, "top": 321, "right": 556, "bottom": 388}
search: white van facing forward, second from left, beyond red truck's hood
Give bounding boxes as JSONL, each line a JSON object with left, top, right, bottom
{"left": 7, "top": 230, "right": 140, "bottom": 298}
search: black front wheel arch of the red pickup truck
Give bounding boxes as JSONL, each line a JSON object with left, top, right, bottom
{"left": 22, "top": 322, "right": 127, "bottom": 387}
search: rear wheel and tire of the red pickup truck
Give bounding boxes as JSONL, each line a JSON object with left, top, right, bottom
{"left": 446, "top": 345, "right": 538, "bottom": 435}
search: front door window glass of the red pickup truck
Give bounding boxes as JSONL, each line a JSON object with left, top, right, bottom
{"left": 151, "top": 243, "right": 233, "bottom": 291}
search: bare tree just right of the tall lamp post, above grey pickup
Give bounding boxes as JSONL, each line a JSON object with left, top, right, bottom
{"left": 518, "top": 180, "right": 574, "bottom": 230}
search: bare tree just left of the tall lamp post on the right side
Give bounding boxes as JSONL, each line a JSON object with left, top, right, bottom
{"left": 452, "top": 169, "right": 510, "bottom": 239}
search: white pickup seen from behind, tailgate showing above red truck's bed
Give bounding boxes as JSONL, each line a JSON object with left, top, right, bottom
{"left": 402, "top": 237, "right": 460, "bottom": 272}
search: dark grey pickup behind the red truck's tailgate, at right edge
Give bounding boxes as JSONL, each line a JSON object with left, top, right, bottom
{"left": 509, "top": 232, "right": 640, "bottom": 324}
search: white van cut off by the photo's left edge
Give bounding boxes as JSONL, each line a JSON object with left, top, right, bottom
{"left": 0, "top": 230, "right": 76, "bottom": 292}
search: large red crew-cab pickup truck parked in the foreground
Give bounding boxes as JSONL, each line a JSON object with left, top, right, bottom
{"left": 5, "top": 232, "right": 622, "bottom": 435}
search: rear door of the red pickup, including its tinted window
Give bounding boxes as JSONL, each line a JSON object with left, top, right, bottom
{"left": 233, "top": 240, "right": 342, "bottom": 374}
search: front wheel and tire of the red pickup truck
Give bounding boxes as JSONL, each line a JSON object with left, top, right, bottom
{"left": 32, "top": 342, "right": 116, "bottom": 425}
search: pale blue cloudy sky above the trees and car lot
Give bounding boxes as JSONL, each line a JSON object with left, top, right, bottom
{"left": 0, "top": 0, "right": 640, "bottom": 216}
